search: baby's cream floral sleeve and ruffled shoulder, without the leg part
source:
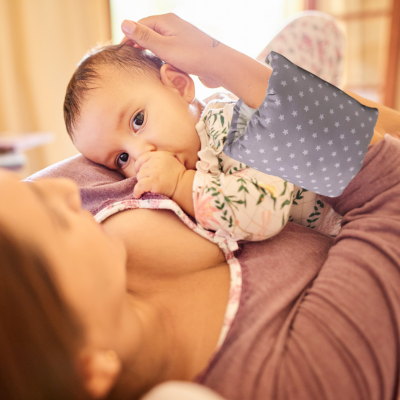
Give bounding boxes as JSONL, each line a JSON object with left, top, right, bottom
{"left": 193, "top": 98, "right": 293, "bottom": 241}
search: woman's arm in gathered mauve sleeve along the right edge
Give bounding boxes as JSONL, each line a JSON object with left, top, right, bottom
{"left": 274, "top": 136, "right": 400, "bottom": 400}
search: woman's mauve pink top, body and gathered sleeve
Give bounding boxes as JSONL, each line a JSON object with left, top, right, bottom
{"left": 195, "top": 135, "right": 400, "bottom": 400}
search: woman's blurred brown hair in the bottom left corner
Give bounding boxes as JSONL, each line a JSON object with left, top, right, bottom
{"left": 0, "top": 225, "right": 89, "bottom": 400}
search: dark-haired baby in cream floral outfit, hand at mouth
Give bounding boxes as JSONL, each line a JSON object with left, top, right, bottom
{"left": 64, "top": 43, "right": 293, "bottom": 241}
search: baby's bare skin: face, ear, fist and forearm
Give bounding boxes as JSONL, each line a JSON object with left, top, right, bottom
{"left": 74, "top": 64, "right": 204, "bottom": 216}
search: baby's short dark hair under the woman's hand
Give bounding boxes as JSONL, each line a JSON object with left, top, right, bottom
{"left": 64, "top": 42, "right": 164, "bottom": 140}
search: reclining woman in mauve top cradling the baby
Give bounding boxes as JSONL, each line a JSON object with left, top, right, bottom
{"left": 0, "top": 15, "right": 400, "bottom": 399}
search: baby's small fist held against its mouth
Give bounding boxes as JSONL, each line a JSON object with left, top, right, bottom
{"left": 133, "top": 151, "right": 186, "bottom": 198}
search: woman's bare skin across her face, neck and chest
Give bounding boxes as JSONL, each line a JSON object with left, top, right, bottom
{"left": 0, "top": 169, "right": 230, "bottom": 398}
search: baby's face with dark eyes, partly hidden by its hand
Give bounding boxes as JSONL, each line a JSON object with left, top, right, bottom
{"left": 74, "top": 66, "right": 200, "bottom": 178}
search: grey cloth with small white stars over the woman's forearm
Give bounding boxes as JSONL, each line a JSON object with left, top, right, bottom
{"left": 223, "top": 51, "right": 378, "bottom": 197}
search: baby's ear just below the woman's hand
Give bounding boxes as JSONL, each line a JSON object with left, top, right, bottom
{"left": 160, "top": 64, "right": 196, "bottom": 103}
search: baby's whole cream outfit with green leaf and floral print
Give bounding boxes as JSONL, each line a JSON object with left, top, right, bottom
{"left": 193, "top": 93, "right": 342, "bottom": 241}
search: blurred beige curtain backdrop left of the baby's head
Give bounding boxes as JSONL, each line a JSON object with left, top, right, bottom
{"left": 0, "top": 0, "right": 111, "bottom": 176}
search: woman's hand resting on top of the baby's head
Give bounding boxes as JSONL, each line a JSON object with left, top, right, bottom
{"left": 121, "top": 13, "right": 221, "bottom": 88}
